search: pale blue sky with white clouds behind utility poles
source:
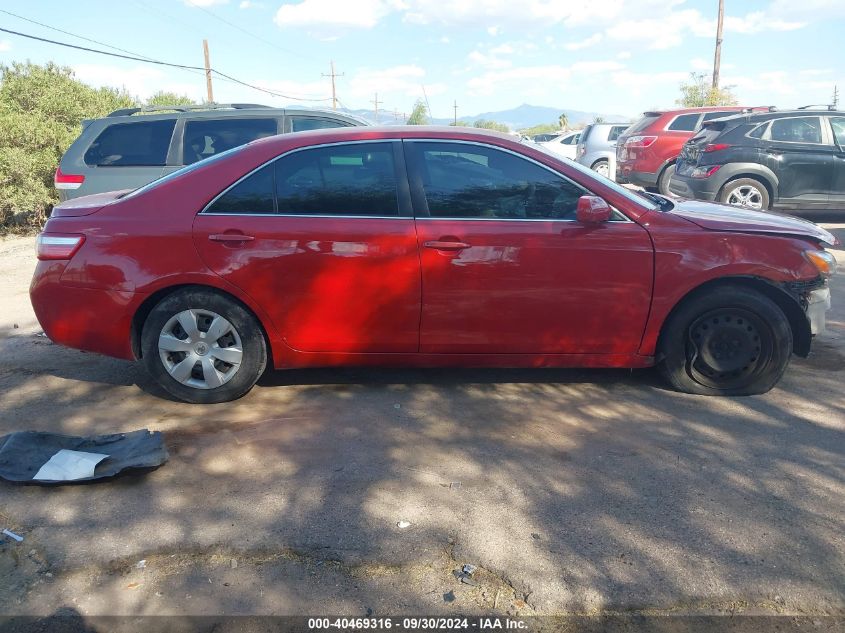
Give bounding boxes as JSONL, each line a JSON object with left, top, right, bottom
{"left": 0, "top": 0, "right": 845, "bottom": 117}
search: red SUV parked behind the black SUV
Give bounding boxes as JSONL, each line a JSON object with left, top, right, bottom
{"left": 616, "top": 106, "right": 768, "bottom": 194}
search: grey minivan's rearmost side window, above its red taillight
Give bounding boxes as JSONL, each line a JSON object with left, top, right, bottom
{"left": 84, "top": 119, "right": 176, "bottom": 167}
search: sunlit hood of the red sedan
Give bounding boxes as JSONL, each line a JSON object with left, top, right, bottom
{"left": 670, "top": 200, "right": 837, "bottom": 246}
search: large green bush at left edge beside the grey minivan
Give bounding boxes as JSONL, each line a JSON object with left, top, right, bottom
{"left": 0, "top": 62, "right": 137, "bottom": 231}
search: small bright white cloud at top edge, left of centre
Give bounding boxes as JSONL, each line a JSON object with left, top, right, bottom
{"left": 275, "top": 0, "right": 398, "bottom": 29}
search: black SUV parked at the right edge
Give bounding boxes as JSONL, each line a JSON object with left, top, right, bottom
{"left": 669, "top": 109, "right": 845, "bottom": 210}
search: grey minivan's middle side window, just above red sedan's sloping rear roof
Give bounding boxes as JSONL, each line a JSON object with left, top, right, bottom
{"left": 182, "top": 117, "right": 278, "bottom": 165}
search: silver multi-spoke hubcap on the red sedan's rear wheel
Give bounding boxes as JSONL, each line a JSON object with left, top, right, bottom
{"left": 158, "top": 310, "right": 244, "bottom": 389}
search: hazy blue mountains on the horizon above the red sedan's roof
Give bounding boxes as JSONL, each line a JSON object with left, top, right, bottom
{"left": 336, "top": 103, "right": 631, "bottom": 130}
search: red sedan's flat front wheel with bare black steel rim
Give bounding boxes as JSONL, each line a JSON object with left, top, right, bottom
{"left": 658, "top": 286, "right": 792, "bottom": 396}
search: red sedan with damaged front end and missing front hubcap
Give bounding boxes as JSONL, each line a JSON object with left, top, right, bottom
{"left": 31, "top": 127, "right": 836, "bottom": 403}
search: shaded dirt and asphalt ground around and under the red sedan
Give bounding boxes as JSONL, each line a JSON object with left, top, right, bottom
{"left": 0, "top": 224, "right": 845, "bottom": 616}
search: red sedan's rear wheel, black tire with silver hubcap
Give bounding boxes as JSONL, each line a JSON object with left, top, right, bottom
{"left": 141, "top": 288, "right": 267, "bottom": 404}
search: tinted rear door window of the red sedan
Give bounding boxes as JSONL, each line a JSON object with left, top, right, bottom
{"left": 276, "top": 143, "right": 399, "bottom": 216}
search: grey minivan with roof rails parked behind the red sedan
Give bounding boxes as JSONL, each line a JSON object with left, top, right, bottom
{"left": 55, "top": 103, "right": 368, "bottom": 200}
